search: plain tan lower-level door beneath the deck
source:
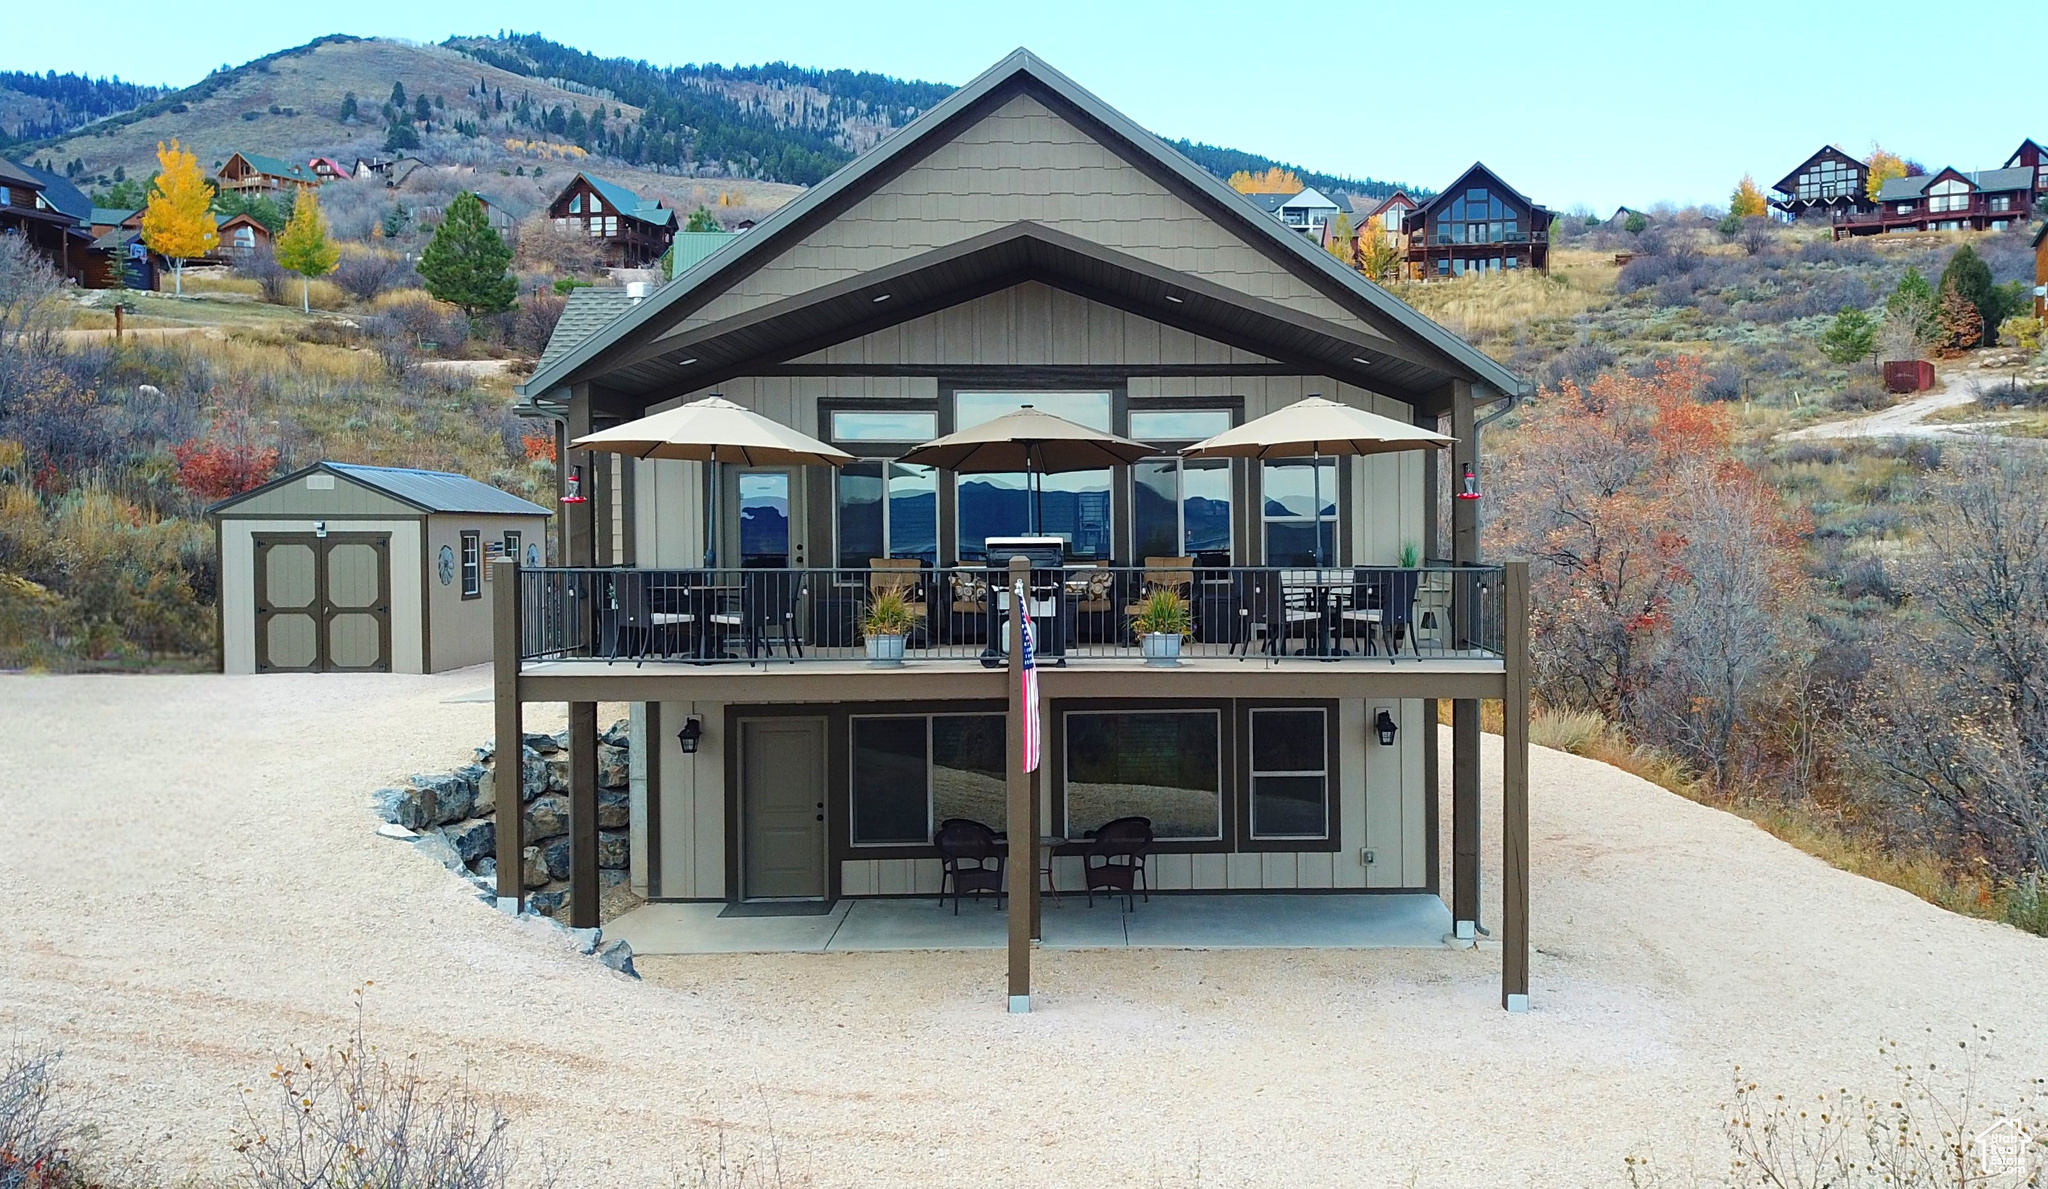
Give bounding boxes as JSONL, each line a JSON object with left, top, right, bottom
{"left": 739, "top": 718, "right": 825, "bottom": 900}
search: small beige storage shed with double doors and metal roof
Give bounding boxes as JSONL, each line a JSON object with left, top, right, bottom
{"left": 209, "top": 463, "right": 549, "bottom": 673}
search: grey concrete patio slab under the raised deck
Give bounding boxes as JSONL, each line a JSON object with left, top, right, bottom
{"left": 604, "top": 892, "right": 1450, "bottom": 954}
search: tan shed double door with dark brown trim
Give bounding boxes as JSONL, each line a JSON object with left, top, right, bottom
{"left": 256, "top": 532, "right": 391, "bottom": 673}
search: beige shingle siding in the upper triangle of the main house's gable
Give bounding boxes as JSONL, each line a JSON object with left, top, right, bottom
{"left": 670, "top": 96, "right": 1386, "bottom": 340}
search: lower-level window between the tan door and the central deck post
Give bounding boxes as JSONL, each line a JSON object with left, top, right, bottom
{"left": 850, "top": 714, "right": 1008, "bottom": 847}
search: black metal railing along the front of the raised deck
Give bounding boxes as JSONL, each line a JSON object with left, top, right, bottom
{"left": 518, "top": 559, "right": 1503, "bottom": 665}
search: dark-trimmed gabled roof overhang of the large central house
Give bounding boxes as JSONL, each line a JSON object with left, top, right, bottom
{"left": 518, "top": 49, "right": 1524, "bottom": 399}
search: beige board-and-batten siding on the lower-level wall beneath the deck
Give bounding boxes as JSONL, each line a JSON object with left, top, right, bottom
{"left": 635, "top": 698, "right": 1434, "bottom": 900}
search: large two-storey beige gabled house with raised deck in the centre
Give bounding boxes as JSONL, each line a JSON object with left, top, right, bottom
{"left": 494, "top": 49, "right": 1540, "bottom": 1011}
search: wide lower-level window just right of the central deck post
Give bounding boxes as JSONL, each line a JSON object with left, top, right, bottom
{"left": 1065, "top": 710, "right": 1223, "bottom": 841}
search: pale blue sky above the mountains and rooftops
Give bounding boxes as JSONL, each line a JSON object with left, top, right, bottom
{"left": 0, "top": 0, "right": 2048, "bottom": 209}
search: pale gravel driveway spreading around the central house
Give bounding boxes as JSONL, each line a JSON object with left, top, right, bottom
{"left": 0, "top": 671, "right": 2048, "bottom": 1187}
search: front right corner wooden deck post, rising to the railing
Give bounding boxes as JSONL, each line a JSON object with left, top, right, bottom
{"left": 1501, "top": 561, "right": 1530, "bottom": 1011}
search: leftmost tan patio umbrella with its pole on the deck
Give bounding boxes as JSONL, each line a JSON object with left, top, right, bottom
{"left": 569, "top": 395, "right": 854, "bottom": 567}
